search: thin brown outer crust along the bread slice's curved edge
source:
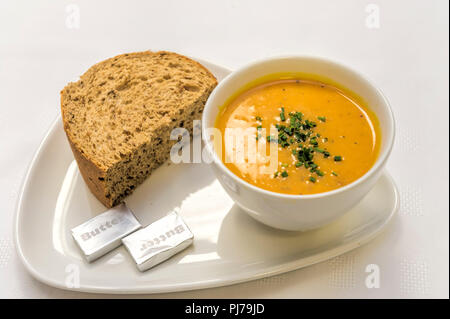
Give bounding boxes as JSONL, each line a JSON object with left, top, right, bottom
{"left": 61, "top": 51, "right": 217, "bottom": 208}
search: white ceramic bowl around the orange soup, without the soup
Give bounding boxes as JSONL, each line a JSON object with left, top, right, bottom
{"left": 202, "top": 56, "right": 395, "bottom": 231}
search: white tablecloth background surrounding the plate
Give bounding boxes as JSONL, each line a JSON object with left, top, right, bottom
{"left": 0, "top": 0, "right": 449, "bottom": 298}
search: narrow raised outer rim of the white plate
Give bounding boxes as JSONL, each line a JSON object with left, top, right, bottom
{"left": 13, "top": 58, "right": 400, "bottom": 294}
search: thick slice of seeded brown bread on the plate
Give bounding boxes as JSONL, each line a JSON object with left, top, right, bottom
{"left": 61, "top": 51, "right": 217, "bottom": 207}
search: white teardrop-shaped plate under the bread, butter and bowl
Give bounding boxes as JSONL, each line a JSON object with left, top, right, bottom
{"left": 15, "top": 61, "right": 398, "bottom": 293}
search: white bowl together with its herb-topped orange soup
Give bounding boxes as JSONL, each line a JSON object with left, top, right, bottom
{"left": 202, "top": 56, "right": 395, "bottom": 231}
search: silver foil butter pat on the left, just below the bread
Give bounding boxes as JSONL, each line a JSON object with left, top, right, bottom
{"left": 72, "top": 203, "right": 141, "bottom": 262}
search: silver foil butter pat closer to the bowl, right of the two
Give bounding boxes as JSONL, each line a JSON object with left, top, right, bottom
{"left": 122, "top": 213, "right": 194, "bottom": 271}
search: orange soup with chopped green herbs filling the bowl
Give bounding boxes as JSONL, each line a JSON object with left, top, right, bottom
{"left": 216, "top": 79, "right": 380, "bottom": 195}
